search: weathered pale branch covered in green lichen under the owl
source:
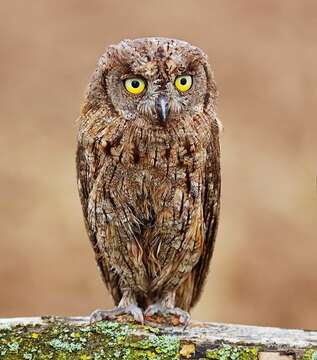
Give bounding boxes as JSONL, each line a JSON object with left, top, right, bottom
{"left": 0, "top": 317, "right": 317, "bottom": 360}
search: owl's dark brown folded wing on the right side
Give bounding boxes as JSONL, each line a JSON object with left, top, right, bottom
{"left": 190, "top": 134, "right": 221, "bottom": 307}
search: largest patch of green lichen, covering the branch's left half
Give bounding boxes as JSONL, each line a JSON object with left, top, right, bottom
{"left": 0, "top": 321, "right": 180, "bottom": 360}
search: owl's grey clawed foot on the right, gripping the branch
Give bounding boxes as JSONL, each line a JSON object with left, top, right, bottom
{"left": 144, "top": 304, "right": 190, "bottom": 327}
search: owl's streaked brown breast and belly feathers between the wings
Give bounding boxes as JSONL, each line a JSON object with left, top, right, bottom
{"left": 90, "top": 117, "right": 208, "bottom": 293}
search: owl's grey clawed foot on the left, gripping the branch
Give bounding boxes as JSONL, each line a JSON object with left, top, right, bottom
{"left": 90, "top": 304, "right": 144, "bottom": 324}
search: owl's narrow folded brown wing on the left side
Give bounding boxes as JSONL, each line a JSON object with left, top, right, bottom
{"left": 76, "top": 129, "right": 121, "bottom": 304}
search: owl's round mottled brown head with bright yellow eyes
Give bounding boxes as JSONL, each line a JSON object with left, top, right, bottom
{"left": 84, "top": 38, "right": 217, "bottom": 126}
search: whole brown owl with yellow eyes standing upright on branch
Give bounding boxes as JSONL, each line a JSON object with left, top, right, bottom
{"left": 76, "top": 37, "right": 220, "bottom": 323}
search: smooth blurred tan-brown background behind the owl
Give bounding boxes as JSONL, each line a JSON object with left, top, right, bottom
{"left": 0, "top": 0, "right": 317, "bottom": 328}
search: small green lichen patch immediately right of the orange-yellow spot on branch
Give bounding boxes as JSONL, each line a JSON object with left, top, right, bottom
{"left": 206, "top": 344, "right": 258, "bottom": 360}
